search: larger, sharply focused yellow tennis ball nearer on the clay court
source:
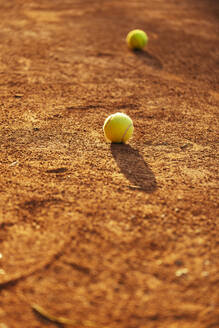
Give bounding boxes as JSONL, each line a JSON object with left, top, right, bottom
{"left": 103, "top": 113, "right": 134, "bottom": 143}
